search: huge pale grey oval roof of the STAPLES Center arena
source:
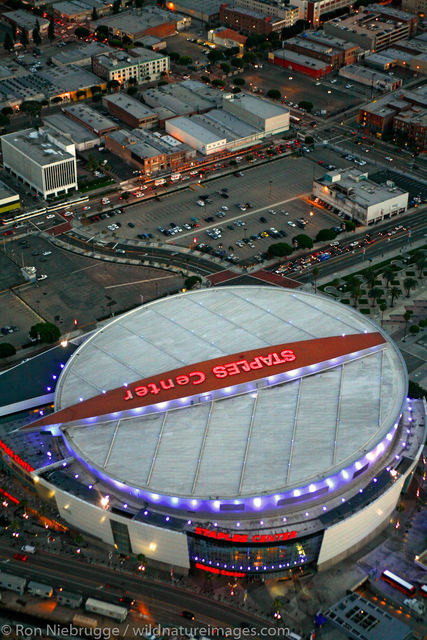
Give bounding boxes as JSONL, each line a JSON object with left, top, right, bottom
{"left": 35, "top": 286, "right": 407, "bottom": 508}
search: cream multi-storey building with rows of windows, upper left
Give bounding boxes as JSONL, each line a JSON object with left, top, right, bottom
{"left": 92, "top": 47, "right": 169, "bottom": 84}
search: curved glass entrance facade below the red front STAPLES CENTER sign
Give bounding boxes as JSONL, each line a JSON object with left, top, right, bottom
{"left": 188, "top": 531, "right": 323, "bottom": 574}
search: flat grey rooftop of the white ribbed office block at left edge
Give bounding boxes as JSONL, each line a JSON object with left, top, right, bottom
{"left": 1, "top": 129, "right": 75, "bottom": 166}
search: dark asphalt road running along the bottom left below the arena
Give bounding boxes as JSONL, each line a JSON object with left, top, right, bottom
{"left": 0, "top": 541, "right": 271, "bottom": 628}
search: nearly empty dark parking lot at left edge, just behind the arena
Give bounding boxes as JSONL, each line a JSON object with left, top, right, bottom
{"left": 0, "top": 236, "right": 183, "bottom": 344}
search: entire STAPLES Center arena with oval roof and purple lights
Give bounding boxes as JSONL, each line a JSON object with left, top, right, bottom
{"left": 0, "top": 286, "right": 425, "bottom": 576}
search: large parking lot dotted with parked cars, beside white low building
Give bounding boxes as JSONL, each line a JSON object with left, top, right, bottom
{"left": 79, "top": 156, "right": 338, "bottom": 261}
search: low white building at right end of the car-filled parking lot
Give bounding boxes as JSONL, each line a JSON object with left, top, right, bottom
{"left": 313, "top": 167, "right": 409, "bottom": 224}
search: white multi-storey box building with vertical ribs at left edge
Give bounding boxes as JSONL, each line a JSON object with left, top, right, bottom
{"left": 1, "top": 129, "right": 77, "bottom": 198}
